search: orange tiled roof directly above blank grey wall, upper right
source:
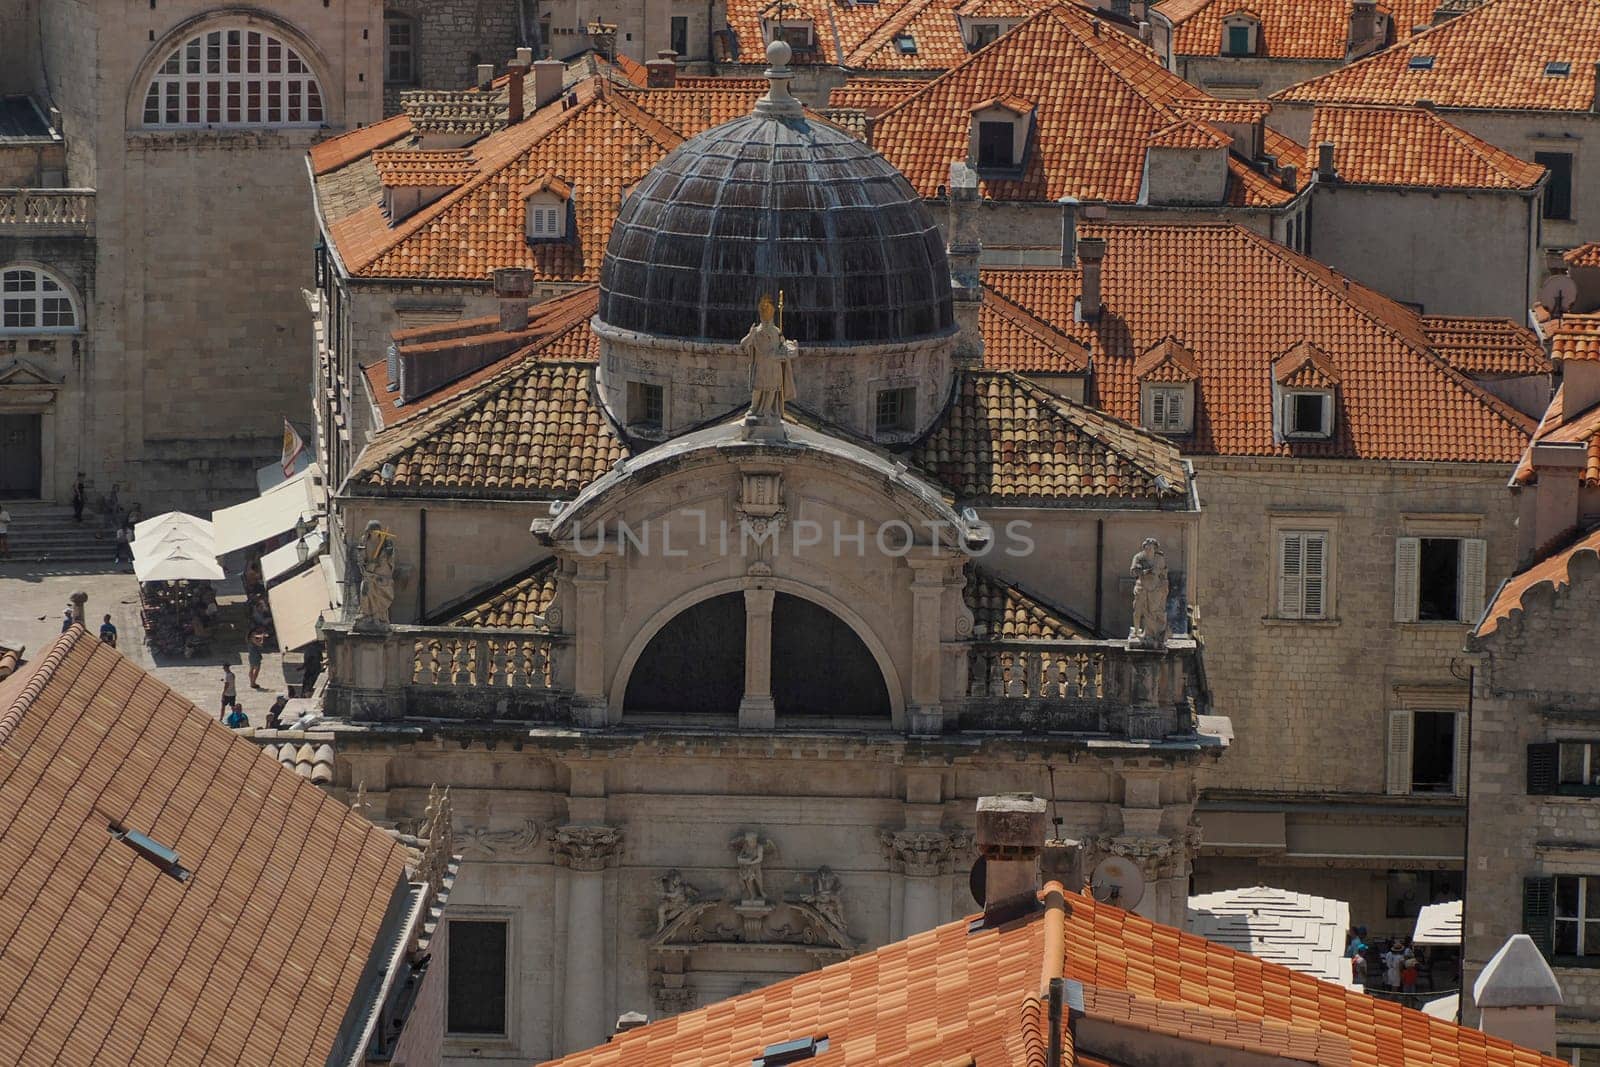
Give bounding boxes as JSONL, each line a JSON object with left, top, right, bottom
{"left": 1304, "top": 104, "right": 1544, "bottom": 189}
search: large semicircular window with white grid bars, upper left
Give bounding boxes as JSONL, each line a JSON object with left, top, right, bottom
{"left": 144, "top": 29, "right": 323, "bottom": 130}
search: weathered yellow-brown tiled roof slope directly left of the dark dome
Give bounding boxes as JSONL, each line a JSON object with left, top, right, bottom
{"left": 347, "top": 358, "right": 626, "bottom": 499}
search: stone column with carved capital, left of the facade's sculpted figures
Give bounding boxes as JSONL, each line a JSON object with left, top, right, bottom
{"left": 552, "top": 824, "right": 622, "bottom": 1054}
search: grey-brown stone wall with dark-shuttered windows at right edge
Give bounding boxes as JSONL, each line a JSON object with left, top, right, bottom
{"left": 1462, "top": 553, "right": 1600, "bottom": 1043}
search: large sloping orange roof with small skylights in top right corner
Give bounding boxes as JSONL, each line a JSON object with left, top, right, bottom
{"left": 1274, "top": 0, "right": 1600, "bottom": 112}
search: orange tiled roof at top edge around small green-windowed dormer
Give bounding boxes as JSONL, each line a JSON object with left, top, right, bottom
{"left": 1155, "top": 0, "right": 1438, "bottom": 62}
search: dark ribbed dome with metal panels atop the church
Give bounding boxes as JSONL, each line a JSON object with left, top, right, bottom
{"left": 600, "top": 107, "right": 954, "bottom": 346}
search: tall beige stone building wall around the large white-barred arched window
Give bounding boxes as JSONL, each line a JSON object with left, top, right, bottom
{"left": 10, "top": 0, "right": 382, "bottom": 512}
